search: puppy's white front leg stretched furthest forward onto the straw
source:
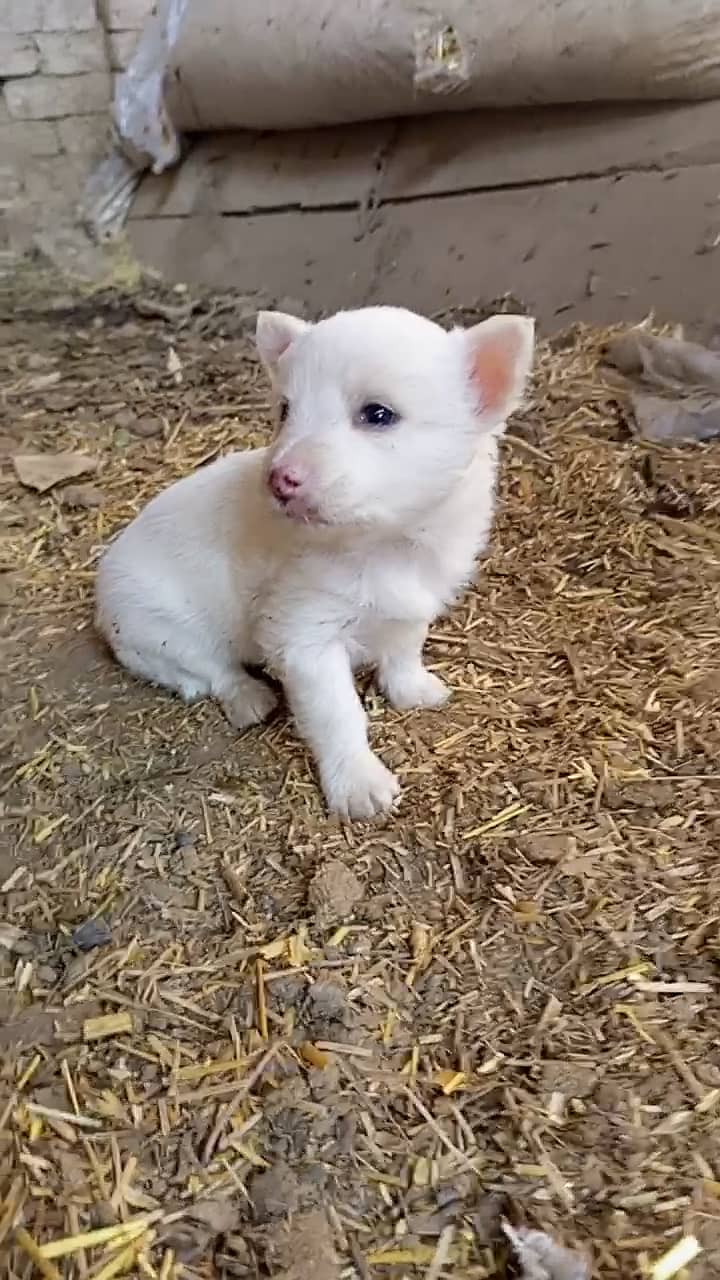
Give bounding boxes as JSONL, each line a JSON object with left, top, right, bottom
{"left": 283, "top": 644, "right": 400, "bottom": 818}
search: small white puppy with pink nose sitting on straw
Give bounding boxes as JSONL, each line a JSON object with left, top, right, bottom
{"left": 96, "top": 307, "right": 533, "bottom": 818}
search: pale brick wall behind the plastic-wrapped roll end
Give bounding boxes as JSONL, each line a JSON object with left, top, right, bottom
{"left": 0, "top": 0, "right": 152, "bottom": 266}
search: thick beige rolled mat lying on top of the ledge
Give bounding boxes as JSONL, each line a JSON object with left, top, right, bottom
{"left": 164, "top": 0, "right": 720, "bottom": 132}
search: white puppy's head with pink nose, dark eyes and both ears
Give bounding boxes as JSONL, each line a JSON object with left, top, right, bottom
{"left": 256, "top": 307, "right": 534, "bottom": 530}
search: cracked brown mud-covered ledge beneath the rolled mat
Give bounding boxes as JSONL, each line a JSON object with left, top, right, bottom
{"left": 129, "top": 102, "right": 720, "bottom": 329}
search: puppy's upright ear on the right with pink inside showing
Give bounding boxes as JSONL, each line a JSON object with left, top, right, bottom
{"left": 462, "top": 316, "right": 536, "bottom": 426}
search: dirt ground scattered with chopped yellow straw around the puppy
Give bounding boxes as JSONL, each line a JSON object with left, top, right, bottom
{"left": 0, "top": 282, "right": 720, "bottom": 1280}
